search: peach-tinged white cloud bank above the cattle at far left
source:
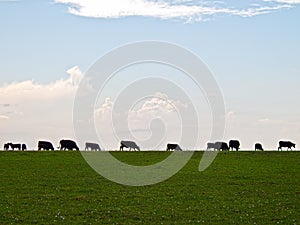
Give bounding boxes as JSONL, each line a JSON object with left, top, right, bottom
{"left": 0, "top": 67, "right": 82, "bottom": 148}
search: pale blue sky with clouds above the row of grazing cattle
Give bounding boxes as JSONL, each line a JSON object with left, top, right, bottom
{"left": 0, "top": 0, "right": 300, "bottom": 149}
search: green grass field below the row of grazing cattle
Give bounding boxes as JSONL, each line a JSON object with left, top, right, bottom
{"left": 0, "top": 151, "right": 300, "bottom": 225}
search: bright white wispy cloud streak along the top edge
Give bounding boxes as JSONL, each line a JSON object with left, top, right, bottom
{"left": 55, "top": 0, "right": 299, "bottom": 22}
